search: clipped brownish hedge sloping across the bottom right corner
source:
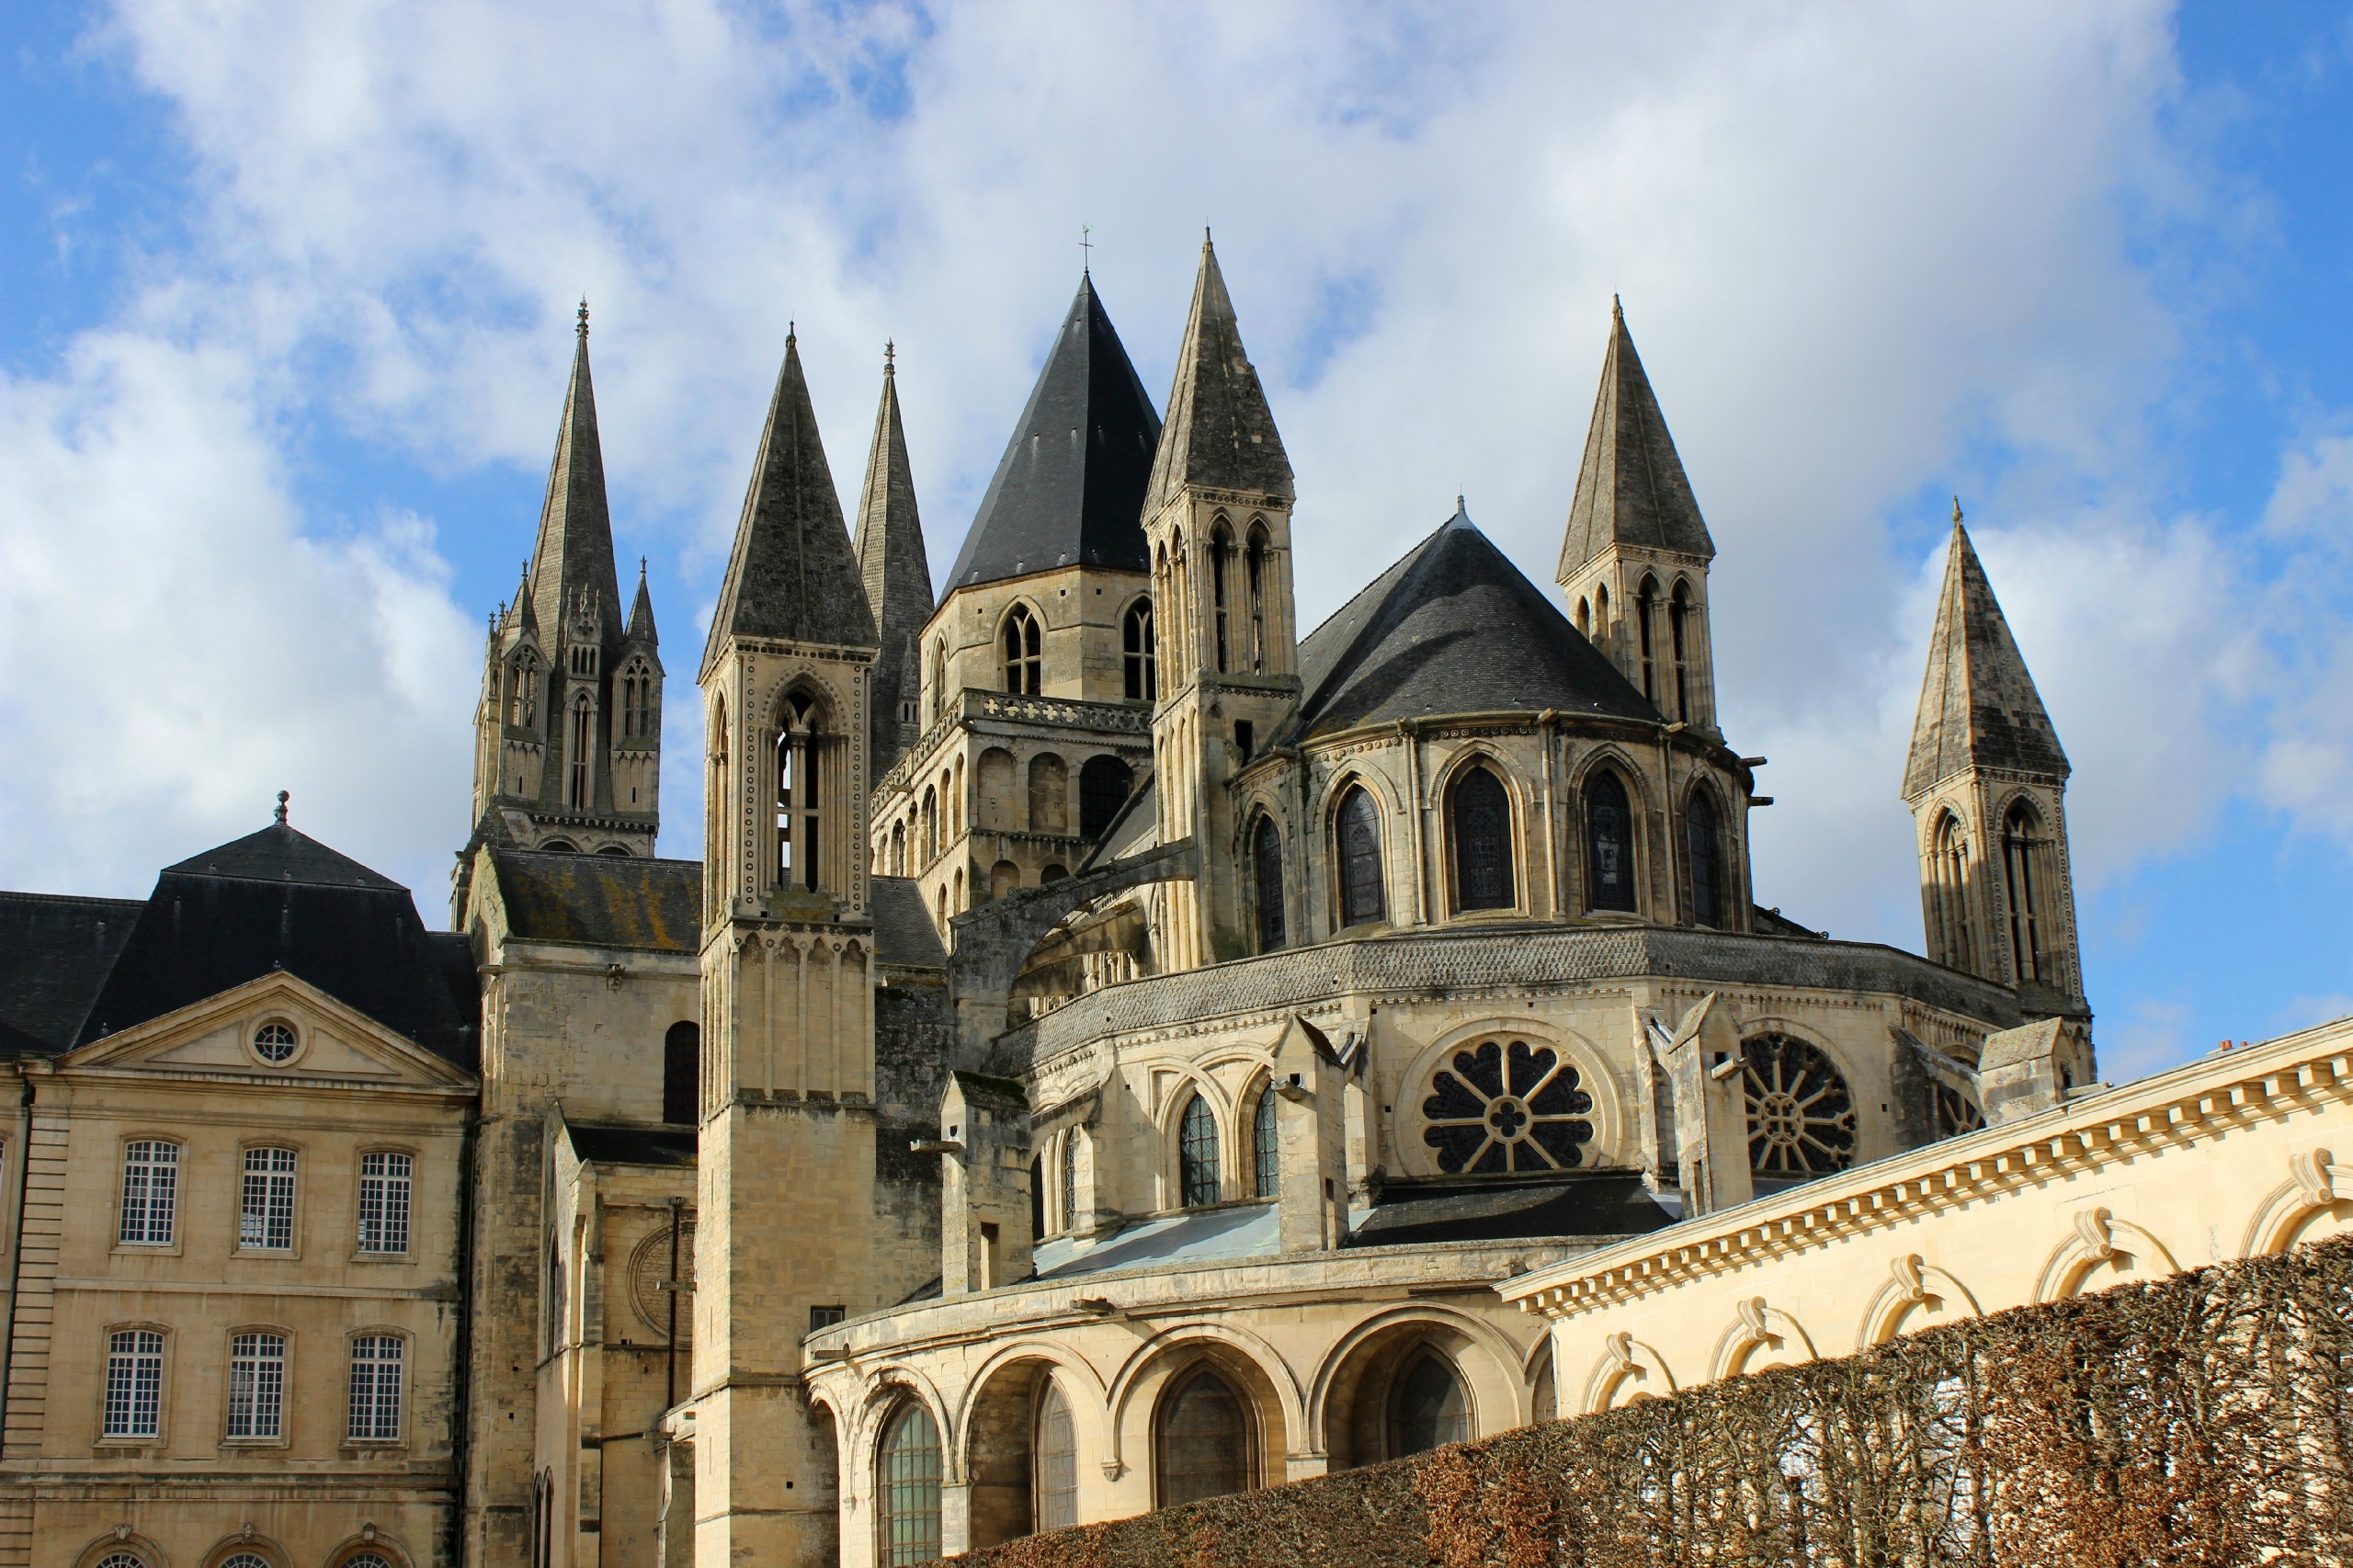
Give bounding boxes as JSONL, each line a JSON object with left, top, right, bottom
{"left": 936, "top": 1238, "right": 2353, "bottom": 1568}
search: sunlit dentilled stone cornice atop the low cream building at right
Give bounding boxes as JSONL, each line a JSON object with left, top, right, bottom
{"left": 1499, "top": 1019, "right": 2353, "bottom": 1318}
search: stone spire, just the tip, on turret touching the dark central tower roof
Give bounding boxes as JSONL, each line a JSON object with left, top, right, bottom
{"left": 1143, "top": 233, "right": 1294, "bottom": 513}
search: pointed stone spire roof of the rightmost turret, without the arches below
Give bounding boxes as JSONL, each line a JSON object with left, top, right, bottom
{"left": 1904, "top": 517, "right": 2068, "bottom": 801}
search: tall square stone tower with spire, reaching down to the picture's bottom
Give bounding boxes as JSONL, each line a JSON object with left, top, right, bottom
{"left": 696, "top": 336, "right": 896, "bottom": 1568}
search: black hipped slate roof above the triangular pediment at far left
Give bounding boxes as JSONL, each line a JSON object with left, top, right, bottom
{"left": 73, "top": 822, "right": 480, "bottom": 1072}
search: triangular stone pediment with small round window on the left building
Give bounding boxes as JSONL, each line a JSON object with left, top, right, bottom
{"left": 59, "top": 972, "right": 473, "bottom": 1087}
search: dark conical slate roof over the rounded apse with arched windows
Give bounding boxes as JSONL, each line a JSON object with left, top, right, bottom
{"left": 1285, "top": 504, "right": 1659, "bottom": 742}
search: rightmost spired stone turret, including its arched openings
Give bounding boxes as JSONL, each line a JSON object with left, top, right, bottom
{"left": 1904, "top": 502, "right": 2083, "bottom": 1012}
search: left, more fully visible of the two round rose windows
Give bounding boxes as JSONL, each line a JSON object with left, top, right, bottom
{"left": 1421, "top": 1040, "right": 1593, "bottom": 1175}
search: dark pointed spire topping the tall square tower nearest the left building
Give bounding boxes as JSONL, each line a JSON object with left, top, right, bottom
{"left": 703, "top": 335, "right": 875, "bottom": 671}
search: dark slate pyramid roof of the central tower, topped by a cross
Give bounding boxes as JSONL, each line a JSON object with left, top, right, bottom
{"left": 949, "top": 276, "right": 1160, "bottom": 594}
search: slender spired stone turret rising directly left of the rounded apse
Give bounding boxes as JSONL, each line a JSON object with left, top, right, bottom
{"left": 1143, "top": 238, "right": 1299, "bottom": 970}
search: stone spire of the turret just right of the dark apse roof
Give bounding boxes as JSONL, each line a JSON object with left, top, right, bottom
{"left": 1558, "top": 299, "right": 1715, "bottom": 582}
